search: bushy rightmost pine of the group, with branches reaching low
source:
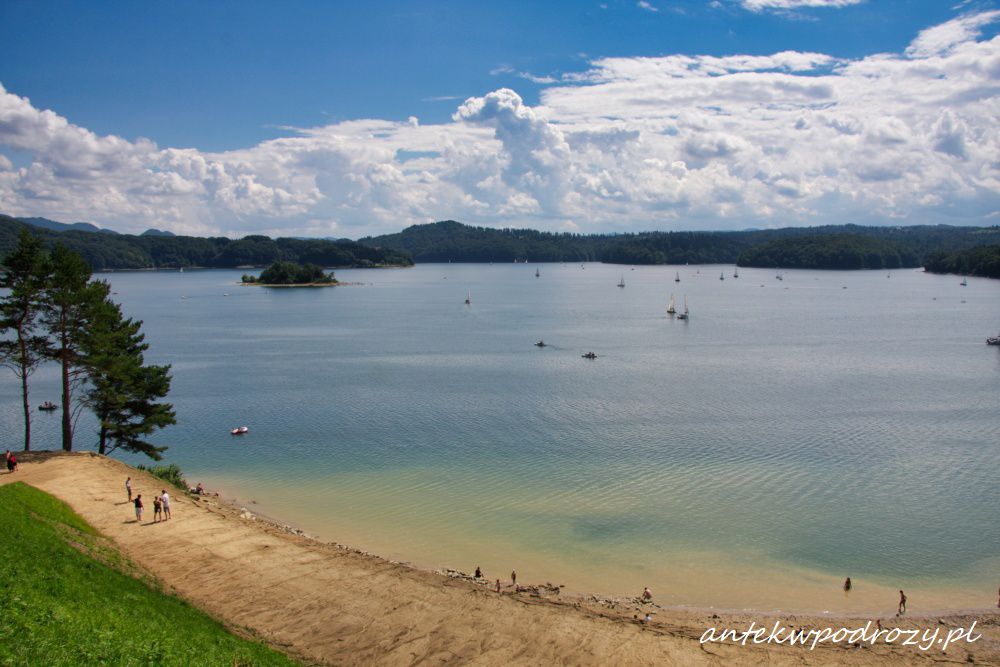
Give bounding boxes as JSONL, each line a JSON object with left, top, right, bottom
{"left": 80, "top": 294, "right": 176, "bottom": 461}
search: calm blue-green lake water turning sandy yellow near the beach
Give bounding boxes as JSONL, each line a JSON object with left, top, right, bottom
{"left": 0, "top": 264, "right": 1000, "bottom": 609}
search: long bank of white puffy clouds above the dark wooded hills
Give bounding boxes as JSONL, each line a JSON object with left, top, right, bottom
{"left": 0, "top": 9, "right": 1000, "bottom": 237}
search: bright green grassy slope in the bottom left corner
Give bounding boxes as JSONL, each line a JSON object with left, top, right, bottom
{"left": 0, "top": 483, "right": 296, "bottom": 666}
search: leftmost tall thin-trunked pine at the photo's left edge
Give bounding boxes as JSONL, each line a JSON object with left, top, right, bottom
{"left": 0, "top": 229, "right": 51, "bottom": 451}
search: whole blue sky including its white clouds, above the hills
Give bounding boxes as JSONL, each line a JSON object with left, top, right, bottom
{"left": 0, "top": 0, "right": 1000, "bottom": 238}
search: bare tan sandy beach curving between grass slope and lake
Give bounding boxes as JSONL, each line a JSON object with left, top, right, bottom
{"left": 0, "top": 453, "right": 1000, "bottom": 665}
